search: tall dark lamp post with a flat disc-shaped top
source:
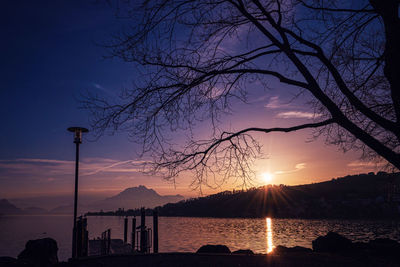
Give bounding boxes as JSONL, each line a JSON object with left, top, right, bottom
{"left": 68, "top": 127, "right": 89, "bottom": 259}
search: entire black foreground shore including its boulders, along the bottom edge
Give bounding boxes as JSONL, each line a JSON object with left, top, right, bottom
{"left": 0, "top": 232, "right": 400, "bottom": 267}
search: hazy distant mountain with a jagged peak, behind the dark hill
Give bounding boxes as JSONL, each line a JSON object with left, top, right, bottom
{"left": 88, "top": 185, "right": 184, "bottom": 211}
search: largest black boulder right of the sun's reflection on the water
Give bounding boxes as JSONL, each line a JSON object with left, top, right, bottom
{"left": 312, "top": 232, "right": 352, "bottom": 252}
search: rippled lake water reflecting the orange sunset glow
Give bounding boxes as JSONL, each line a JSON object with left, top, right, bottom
{"left": 0, "top": 215, "right": 400, "bottom": 260}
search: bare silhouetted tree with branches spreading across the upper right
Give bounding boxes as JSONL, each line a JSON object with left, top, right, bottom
{"left": 84, "top": 0, "right": 400, "bottom": 188}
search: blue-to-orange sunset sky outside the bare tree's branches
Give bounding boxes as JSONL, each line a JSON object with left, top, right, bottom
{"left": 0, "top": 0, "right": 377, "bottom": 205}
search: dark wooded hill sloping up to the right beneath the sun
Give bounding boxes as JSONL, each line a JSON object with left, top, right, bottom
{"left": 157, "top": 172, "right": 400, "bottom": 219}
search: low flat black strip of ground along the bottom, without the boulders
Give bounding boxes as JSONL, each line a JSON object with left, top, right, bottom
{"left": 57, "top": 252, "right": 400, "bottom": 267}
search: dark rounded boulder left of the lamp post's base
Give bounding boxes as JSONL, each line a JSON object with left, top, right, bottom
{"left": 18, "top": 238, "right": 58, "bottom": 266}
